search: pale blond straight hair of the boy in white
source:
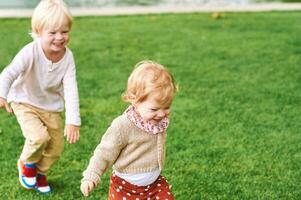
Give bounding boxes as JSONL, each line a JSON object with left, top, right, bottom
{"left": 31, "top": 0, "right": 73, "bottom": 38}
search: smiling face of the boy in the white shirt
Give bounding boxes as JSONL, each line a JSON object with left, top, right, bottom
{"left": 39, "top": 23, "right": 70, "bottom": 58}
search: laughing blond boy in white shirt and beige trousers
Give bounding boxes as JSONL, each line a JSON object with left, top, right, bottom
{"left": 0, "top": 0, "right": 81, "bottom": 193}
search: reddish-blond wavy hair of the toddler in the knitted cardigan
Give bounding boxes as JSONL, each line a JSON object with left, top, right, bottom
{"left": 122, "top": 60, "right": 177, "bottom": 105}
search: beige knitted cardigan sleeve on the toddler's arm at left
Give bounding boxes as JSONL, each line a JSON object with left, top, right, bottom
{"left": 81, "top": 119, "right": 123, "bottom": 184}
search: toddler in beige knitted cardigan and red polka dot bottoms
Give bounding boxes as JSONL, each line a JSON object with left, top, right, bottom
{"left": 81, "top": 61, "right": 176, "bottom": 200}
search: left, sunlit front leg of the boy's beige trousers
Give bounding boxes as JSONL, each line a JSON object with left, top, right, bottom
{"left": 12, "top": 103, "right": 50, "bottom": 163}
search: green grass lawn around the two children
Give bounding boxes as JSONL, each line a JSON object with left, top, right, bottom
{"left": 0, "top": 12, "right": 301, "bottom": 200}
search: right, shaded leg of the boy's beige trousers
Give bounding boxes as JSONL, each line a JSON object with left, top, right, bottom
{"left": 37, "top": 112, "right": 64, "bottom": 174}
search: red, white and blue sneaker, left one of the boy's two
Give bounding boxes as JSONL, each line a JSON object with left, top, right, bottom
{"left": 17, "top": 160, "right": 37, "bottom": 189}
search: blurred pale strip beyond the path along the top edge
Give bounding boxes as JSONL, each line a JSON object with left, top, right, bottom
{"left": 0, "top": 0, "right": 301, "bottom": 8}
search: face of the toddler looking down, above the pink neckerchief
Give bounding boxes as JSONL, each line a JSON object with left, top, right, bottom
{"left": 134, "top": 97, "right": 170, "bottom": 124}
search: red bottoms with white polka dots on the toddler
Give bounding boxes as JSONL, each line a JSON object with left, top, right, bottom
{"left": 108, "top": 173, "right": 175, "bottom": 200}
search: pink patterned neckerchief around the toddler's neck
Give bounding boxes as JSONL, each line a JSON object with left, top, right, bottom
{"left": 125, "top": 105, "right": 169, "bottom": 134}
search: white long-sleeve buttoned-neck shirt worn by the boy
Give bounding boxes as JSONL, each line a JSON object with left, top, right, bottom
{"left": 0, "top": 40, "right": 81, "bottom": 125}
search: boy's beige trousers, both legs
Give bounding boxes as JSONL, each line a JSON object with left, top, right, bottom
{"left": 11, "top": 103, "right": 64, "bottom": 174}
